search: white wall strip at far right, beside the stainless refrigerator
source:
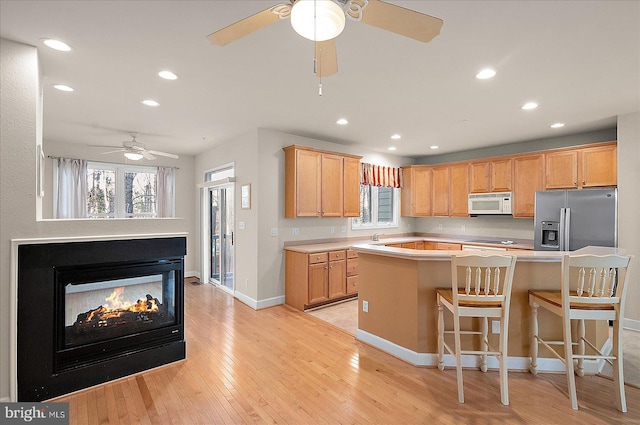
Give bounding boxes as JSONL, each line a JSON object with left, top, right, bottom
{"left": 618, "top": 112, "right": 640, "bottom": 324}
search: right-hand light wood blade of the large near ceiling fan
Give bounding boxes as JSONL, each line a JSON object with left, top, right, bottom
{"left": 362, "top": 0, "right": 443, "bottom": 43}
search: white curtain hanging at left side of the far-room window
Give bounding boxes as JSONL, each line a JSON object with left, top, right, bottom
{"left": 55, "top": 158, "right": 87, "bottom": 218}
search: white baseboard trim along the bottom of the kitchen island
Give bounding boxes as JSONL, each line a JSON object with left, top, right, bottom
{"left": 356, "top": 329, "right": 601, "bottom": 375}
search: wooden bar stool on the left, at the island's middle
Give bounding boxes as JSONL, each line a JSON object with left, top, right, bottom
{"left": 436, "top": 255, "right": 516, "bottom": 405}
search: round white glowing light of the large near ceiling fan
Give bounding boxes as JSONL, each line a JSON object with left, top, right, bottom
{"left": 291, "top": 0, "right": 345, "bottom": 41}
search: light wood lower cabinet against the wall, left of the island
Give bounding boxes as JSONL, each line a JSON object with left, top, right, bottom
{"left": 285, "top": 250, "right": 358, "bottom": 310}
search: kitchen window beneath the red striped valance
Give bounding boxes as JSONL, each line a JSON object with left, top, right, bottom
{"left": 351, "top": 185, "right": 400, "bottom": 229}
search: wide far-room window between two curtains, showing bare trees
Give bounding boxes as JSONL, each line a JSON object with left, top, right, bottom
{"left": 87, "top": 162, "right": 158, "bottom": 218}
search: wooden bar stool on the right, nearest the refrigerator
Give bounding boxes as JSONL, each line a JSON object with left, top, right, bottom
{"left": 529, "top": 255, "right": 631, "bottom": 412}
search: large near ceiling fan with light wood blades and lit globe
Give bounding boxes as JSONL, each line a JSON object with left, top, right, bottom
{"left": 207, "top": 0, "right": 443, "bottom": 77}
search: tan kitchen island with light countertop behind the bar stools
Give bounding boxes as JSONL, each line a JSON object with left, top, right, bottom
{"left": 354, "top": 244, "right": 617, "bottom": 373}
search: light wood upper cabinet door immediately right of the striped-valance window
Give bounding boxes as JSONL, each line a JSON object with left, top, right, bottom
{"left": 400, "top": 165, "right": 431, "bottom": 217}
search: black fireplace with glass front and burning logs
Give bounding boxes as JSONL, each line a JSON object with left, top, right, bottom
{"left": 17, "top": 237, "right": 186, "bottom": 401}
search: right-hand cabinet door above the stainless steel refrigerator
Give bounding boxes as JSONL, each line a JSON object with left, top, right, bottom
{"left": 579, "top": 145, "right": 618, "bottom": 187}
